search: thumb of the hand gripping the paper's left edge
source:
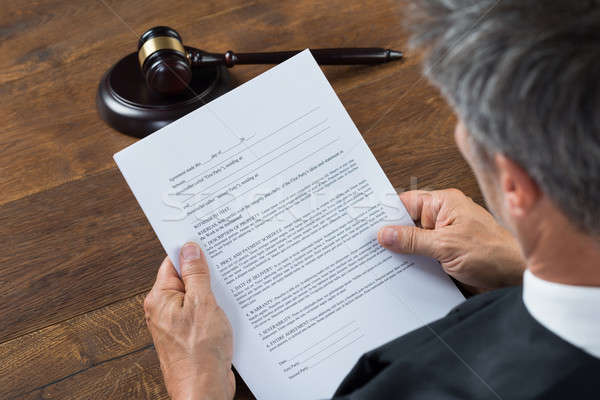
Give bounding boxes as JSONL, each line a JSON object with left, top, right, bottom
{"left": 179, "top": 242, "right": 210, "bottom": 294}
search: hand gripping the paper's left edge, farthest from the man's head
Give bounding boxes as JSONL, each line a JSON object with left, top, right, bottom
{"left": 144, "top": 243, "right": 235, "bottom": 400}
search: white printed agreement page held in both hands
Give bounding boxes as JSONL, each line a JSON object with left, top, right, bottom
{"left": 115, "top": 50, "right": 463, "bottom": 400}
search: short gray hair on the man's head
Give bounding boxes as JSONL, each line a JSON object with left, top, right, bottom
{"left": 409, "top": 0, "right": 600, "bottom": 235}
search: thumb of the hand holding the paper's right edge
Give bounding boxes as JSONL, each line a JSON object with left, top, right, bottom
{"left": 377, "top": 226, "right": 438, "bottom": 258}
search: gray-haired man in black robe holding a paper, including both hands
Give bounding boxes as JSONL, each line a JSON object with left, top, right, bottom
{"left": 145, "top": 0, "right": 600, "bottom": 400}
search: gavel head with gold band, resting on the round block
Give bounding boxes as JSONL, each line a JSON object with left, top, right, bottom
{"left": 138, "top": 26, "right": 192, "bottom": 94}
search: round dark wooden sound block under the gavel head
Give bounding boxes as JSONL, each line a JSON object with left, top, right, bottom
{"left": 96, "top": 53, "right": 232, "bottom": 138}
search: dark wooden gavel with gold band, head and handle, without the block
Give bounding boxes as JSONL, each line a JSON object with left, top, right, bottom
{"left": 137, "top": 26, "right": 403, "bottom": 95}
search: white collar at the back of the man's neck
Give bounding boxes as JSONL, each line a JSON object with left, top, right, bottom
{"left": 523, "top": 270, "right": 600, "bottom": 358}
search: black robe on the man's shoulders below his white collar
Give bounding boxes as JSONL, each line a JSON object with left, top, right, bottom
{"left": 335, "top": 287, "right": 600, "bottom": 400}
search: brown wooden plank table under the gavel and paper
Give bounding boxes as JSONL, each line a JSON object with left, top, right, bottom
{"left": 0, "top": 0, "right": 481, "bottom": 399}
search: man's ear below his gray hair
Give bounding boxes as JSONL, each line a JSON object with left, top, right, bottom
{"left": 494, "top": 153, "right": 541, "bottom": 218}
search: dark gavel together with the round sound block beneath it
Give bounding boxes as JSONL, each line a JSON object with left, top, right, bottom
{"left": 96, "top": 26, "right": 403, "bottom": 137}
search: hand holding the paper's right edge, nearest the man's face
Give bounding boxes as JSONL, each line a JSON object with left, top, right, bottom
{"left": 378, "top": 189, "right": 525, "bottom": 290}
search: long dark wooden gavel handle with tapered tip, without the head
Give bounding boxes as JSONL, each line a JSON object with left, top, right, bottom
{"left": 186, "top": 47, "right": 403, "bottom": 68}
